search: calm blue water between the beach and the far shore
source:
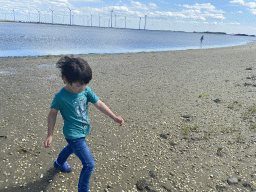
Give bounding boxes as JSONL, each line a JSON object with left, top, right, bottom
{"left": 0, "top": 22, "right": 256, "bottom": 57}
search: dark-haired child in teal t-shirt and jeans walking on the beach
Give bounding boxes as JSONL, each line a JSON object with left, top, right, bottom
{"left": 44, "top": 56, "right": 124, "bottom": 192}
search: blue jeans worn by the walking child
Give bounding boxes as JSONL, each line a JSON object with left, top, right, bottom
{"left": 57, "top": 137, "right": 95, "bottom": 192}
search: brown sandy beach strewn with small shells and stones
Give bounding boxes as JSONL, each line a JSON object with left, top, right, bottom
{"left": 0, "top": 44, "right": 256, "bottom": 192}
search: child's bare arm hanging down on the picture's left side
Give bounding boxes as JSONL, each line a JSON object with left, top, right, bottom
{"left": 44, "top": 108, "right": 58, "bottom": 148}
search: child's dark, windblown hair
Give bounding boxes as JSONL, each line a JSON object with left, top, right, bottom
{"left": 56, "top": 56, "right": 92, "bottom": 84}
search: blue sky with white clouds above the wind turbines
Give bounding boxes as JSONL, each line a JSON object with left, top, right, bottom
{"left": 0, "top": 0, "right": 256, "bottom": 35}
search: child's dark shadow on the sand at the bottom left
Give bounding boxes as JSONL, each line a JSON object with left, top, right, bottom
{"left": 0, "top": 167, "right": 59, "bottom": 192}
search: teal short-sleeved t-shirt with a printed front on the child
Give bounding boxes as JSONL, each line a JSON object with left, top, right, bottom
{"left": 51, "top": 86, "right": 99, "bottom": 139}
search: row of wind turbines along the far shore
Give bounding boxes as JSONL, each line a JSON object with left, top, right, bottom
{"left": 10, "top": 7, "right": 147, "bottom": 30}
